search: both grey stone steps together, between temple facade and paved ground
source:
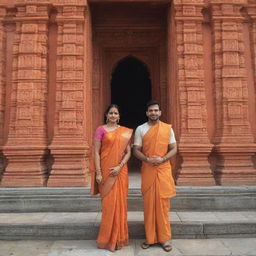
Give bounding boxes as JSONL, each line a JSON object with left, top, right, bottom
{"left": 0, "top": 186, "right": 256, "bottom": 240}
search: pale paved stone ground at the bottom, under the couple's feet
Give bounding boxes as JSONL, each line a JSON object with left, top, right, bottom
{"left": 0, "top": 238, "right": 256, "bottom": 256}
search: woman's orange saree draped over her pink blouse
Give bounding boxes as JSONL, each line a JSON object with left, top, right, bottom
{"left": 92, "top": 126, "right": 132, "bottom": 251}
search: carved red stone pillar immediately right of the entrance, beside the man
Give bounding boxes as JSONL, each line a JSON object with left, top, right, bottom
{"left": 174, "top": 0, "right": 215, "bottom": 185}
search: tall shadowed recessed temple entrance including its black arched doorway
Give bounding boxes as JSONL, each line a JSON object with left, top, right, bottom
{"left": 90, "top": 1, "right": 170, "bottom": 174}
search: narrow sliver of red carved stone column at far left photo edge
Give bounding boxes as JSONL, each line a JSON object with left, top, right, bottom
{"left": 0, "top": 6, "right": 6, "bottom": 181}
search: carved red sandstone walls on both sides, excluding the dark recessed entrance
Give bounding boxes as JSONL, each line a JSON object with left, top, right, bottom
{"left": 0, "top": 0, "right": 256, "bottom": 186}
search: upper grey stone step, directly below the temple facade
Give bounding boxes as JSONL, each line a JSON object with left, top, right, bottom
{"left": 0, "top": 186, "right": 256, "bottom": 213}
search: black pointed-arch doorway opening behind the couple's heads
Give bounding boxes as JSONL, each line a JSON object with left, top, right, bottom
{"left": 111, "top": 56, "right": 151, "bottom": 129}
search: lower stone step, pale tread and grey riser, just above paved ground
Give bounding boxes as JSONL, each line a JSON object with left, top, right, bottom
{"left": 0, "top": 211, "right": 256, "bottom": 240}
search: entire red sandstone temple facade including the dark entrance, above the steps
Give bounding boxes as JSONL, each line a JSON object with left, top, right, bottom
{"left": 0, "top": 0, "right": 256, "bottom": 187}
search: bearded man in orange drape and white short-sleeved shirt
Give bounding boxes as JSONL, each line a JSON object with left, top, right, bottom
{"left": 134, "top": 101, "right": 177, "bottom": 252}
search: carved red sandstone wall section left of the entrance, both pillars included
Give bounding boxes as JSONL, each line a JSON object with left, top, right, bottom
{"left": 0, "top": 1, "right": 91, "bottom": 186}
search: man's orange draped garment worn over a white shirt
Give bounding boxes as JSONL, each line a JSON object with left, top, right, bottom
{"left": 141, "top": 121, "right": 176, "bottom": 244}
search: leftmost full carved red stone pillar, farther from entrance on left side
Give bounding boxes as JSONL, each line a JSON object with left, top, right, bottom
{"left": 1, "top": 0, "right": 48, "bottom": 186}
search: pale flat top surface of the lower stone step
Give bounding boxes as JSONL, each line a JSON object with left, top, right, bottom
{"left": 0, "top": 211, "right": 256, "bottom": 224}
